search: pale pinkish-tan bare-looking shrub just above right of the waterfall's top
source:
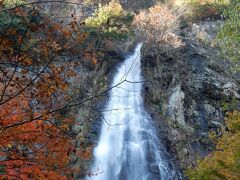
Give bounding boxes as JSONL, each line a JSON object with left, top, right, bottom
{"left": 134, "top": 4, "right": 186, "bottom": 52}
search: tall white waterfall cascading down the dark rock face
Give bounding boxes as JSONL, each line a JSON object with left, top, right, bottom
{"left": 87, "top": 44, "right": 178, "bottom": 180}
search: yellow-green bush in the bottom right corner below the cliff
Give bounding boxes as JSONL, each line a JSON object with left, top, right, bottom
{"left": 187, "top": 111, "right": 240, "bottom": 180}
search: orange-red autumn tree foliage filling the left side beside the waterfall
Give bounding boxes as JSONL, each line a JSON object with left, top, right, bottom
{"left": 0, "top": 3, "right": 93, "bottom": 179}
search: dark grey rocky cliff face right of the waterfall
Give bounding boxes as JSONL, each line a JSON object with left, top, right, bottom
{"left": 142, "top": 22, "right": 240, "bottom": 169}
